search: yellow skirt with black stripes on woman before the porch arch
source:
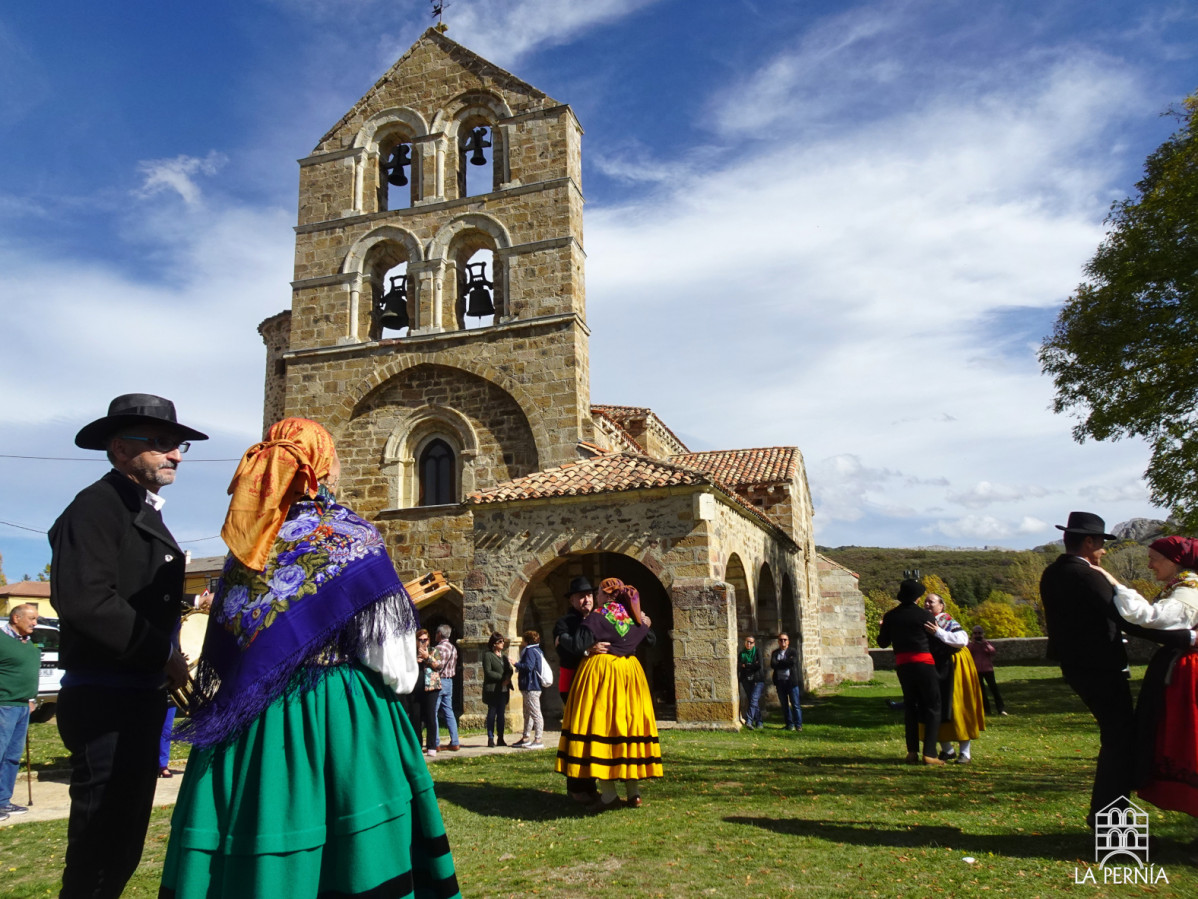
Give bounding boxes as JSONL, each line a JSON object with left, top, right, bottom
{"left": 556, "top": 654, "right": 661, "bottom": 780}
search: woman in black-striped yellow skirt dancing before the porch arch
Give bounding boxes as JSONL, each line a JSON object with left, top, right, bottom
{"left": 556, "top": 578, "right": 661, "bottom": 808}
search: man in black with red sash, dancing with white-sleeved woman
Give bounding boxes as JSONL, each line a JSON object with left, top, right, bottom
{"left": 878, "top": 578, "right": 944, "bottom": 765}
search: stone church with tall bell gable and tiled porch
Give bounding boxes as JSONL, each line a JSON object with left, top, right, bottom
{"left": 259, "top": 29, "right": 871, "bottom": 728}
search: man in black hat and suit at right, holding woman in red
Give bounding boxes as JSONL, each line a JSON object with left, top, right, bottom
{"left": 1040, "top": 512, "right": 1192, "bottom": 829}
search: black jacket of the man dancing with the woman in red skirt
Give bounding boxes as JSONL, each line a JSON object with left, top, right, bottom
{"left": 1040, "top": 554, "right": 1190, "bottom": 671}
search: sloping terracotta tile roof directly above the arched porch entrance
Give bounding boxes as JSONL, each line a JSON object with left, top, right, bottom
{"left": 466, "top": 453, "right": 712, "bottom": 503}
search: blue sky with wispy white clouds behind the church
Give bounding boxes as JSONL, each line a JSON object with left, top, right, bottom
{"left": 0, "top": 0, "right": 1198, "bottom": 580}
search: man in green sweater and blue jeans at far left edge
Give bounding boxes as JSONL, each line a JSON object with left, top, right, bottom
{"left": 0, "top": 603, "right": 42, "bottom": 821}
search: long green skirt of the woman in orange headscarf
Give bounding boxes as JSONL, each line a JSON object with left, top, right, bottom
{"left": 159, "top": 666, "right": 460, "bottom": 899}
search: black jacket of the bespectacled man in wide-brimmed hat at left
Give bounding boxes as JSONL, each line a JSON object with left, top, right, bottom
{"left": 50, "top": 470, "right": 186, "bottom": 671}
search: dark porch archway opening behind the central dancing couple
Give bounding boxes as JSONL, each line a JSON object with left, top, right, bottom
{"left": 514, "top": 553, "right": 677, "bottom": 728}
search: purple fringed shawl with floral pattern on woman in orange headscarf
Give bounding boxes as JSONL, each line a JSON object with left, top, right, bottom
{"left": 176, "top": 499, "right": 417, "bottom": 746}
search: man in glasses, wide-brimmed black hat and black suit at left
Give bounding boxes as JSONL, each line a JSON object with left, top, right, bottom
{"left": 50, "top": 393, "right": 207, "bottom": 899}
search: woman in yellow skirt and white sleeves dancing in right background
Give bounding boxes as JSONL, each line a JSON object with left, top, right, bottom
{"left": 924, "top": 593, "right": 986, "bottom": 765}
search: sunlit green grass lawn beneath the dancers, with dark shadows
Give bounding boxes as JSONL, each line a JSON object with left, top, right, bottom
{"left": 0, "top": 668, "right": 1198, "bottom": 899}
